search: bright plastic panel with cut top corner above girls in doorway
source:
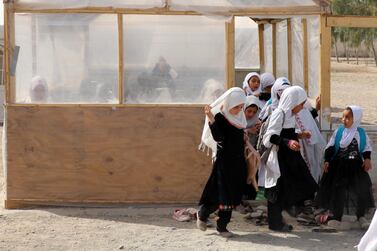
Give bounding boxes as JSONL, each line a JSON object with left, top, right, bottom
{"left": 235, "top": 17, "right": 259, "bottom": 69}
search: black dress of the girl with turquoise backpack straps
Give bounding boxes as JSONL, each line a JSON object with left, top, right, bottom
{"left": 316, "top": 138, "right": 374, "bottom": 221}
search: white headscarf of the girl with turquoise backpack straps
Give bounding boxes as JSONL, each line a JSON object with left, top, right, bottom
{"left": 326, "top": 105, "right": 372, "bottom": 152}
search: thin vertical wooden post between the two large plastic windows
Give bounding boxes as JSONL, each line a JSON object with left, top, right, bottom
{"left": 118, "top": 14, "right": 125, "bottom": 104}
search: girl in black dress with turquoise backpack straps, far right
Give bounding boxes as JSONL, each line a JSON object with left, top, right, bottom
{"left": 316, "top": 105, "right": 374, "bottom": 228}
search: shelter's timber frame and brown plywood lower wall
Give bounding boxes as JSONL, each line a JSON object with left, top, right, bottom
{"left": 4, "top": 0, "right": 333, "bottom": 208}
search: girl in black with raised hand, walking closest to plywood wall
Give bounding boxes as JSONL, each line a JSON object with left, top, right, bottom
{"left": 197, "top": 87, "right": 247, "bottom": 237}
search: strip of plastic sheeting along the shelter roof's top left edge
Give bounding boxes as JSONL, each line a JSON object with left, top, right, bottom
{"left": 15, "top": 0, "right": 165, "bottom": 9}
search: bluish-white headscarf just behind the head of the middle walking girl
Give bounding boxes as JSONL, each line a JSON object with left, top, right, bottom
{"left": 259, "top": 77, "right": 291, "bottom": 121}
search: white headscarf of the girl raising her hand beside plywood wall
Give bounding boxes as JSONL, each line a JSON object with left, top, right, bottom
{"left": 199, "top": 87, "right": 247, "bottom": 157}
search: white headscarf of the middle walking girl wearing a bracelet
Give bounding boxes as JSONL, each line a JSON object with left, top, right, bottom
{"left": 263, "top": 86, "right": 307, "bottom": 147}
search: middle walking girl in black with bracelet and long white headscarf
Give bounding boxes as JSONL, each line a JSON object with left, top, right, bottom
{"left": 263, "top": 86, "right": 317, "bottom": 232}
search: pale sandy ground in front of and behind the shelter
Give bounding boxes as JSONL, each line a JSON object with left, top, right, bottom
{"left": 0, "top": 61, "right": 377, "bottom": 251}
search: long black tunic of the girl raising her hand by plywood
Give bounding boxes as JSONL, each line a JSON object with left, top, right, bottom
{"left": 199, "top": 113, "right": 246, "bottom": 210}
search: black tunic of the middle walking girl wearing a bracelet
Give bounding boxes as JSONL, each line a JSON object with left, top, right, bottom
{"left": 266, "top": 128, "right": 317, "bottom": 208}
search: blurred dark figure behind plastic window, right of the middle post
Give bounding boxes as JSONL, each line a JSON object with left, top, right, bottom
{"left": 151, "top": 57, "right": 178, "bottom": 101}
